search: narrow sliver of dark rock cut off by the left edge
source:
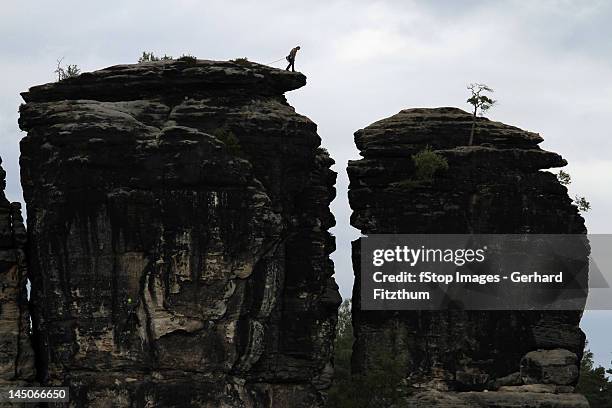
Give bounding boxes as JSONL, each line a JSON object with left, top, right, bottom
{"left": 0, "top": 155, "right": 34, "bottom": 388}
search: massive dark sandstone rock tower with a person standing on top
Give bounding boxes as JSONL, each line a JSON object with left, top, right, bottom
{"left": 19, "top": 60, "right": 340, "bottom": 407}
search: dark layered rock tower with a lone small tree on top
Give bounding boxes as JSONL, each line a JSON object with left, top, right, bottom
{"left": 348, "top": 108, "right": 588, "bottom": 407}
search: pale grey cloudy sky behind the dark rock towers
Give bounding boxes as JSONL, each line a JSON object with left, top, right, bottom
{"left": 0, "top": 0, "right": 612, "bottom": 366}
